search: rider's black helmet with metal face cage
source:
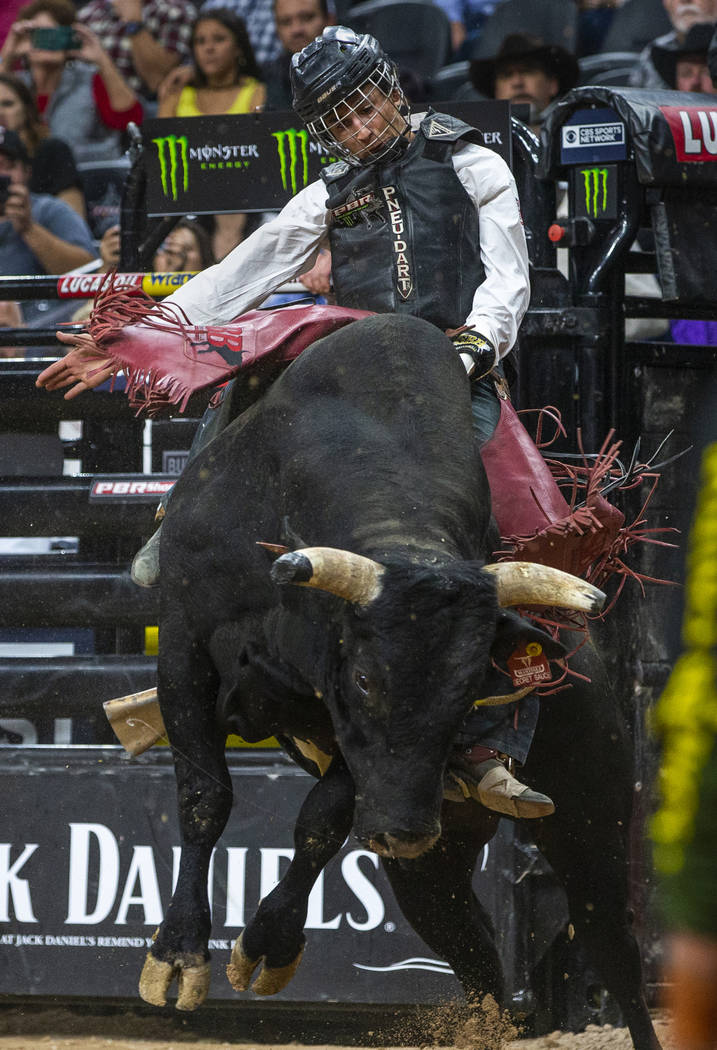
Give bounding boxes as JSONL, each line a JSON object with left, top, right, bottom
{"left": 291, "top": 25, "right": 409, "bottom": 164}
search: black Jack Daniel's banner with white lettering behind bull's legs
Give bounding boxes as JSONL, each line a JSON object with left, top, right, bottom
{"left": 0, "top": 747, "right": 550, "bottom": 1003}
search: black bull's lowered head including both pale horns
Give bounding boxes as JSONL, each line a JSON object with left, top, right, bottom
{"left": 272, "top": 547, "right": 605, "bottom": 857}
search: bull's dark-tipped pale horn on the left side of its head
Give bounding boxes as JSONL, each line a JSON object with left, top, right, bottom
{"left": 271, "top": 547, "right": 384, "bottom": 605}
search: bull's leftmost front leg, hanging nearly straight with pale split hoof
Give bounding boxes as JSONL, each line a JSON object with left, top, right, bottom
{"left": 140, "top": 626, "right": 232, "bottom": 1010}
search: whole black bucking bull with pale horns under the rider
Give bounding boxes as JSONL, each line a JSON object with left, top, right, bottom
{"left": 141, "top": 316, "right": 658, "bottom": 1050}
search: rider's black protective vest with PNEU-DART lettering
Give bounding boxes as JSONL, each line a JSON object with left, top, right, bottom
{"left": 321, "top": 112, "right": 485, "bottom": 330}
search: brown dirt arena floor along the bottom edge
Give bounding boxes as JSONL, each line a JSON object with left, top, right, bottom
{"left": 0, "top": 1004, "right": 674, "bottom": 1050}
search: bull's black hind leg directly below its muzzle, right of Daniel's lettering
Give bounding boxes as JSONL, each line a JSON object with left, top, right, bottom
{"left": 382, "top": 802, "right": 503, "bottom": 1004}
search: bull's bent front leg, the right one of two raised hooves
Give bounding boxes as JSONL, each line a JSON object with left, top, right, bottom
{"left": 227, "top": 755, "right": 354, "bottom": 995}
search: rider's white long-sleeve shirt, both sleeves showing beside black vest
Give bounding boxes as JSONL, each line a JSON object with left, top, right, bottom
{"left": 165, "top": 137, "right": 530, "bottom": 358}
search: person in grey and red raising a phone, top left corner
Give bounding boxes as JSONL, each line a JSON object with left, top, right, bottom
{"left": 0, "top": 0, "right": 143, "bottom": 162}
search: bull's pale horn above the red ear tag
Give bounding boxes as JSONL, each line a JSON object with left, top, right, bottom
{"left": 483, "top": 562, "right": 606, "bottom": 613}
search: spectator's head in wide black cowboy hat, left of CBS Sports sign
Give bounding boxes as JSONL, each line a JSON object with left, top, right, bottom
{"left": 470, "top": 33, "right": 579, "bottom": 130}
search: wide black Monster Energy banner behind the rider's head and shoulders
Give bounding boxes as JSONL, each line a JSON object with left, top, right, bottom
{"left": 142, "top": 102, "right": 510, "bottom": 215}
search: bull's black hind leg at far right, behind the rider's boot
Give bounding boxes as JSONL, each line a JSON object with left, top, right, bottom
{"left": 526, "top": 648, "right": 659, "bottom": 1050}
